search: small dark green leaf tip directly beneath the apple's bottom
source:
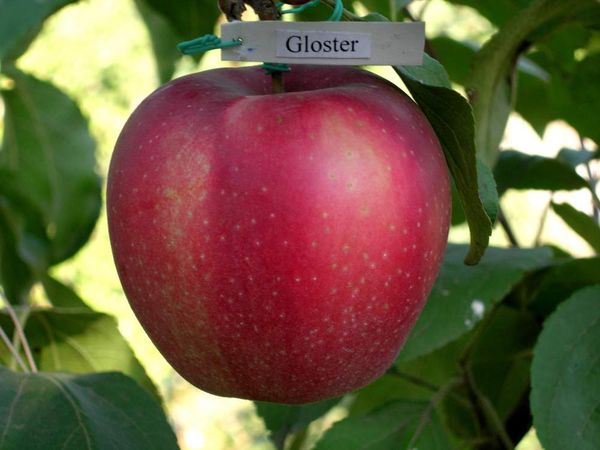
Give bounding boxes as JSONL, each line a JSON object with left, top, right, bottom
{"left": 254, "top": 398, "right": 340, "bottom": 448}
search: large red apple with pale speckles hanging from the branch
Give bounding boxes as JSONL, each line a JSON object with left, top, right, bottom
{"left": 107, "top": 66, "right": 451, "bottom": 403}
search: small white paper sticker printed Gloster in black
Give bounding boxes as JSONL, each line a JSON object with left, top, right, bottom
{"left": 276, "top": 30, "right": 371, "bottom": 59}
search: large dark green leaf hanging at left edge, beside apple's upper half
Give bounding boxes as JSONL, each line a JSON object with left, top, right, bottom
{"left": 0, "top": 69, "right": 101, "bottom": 269}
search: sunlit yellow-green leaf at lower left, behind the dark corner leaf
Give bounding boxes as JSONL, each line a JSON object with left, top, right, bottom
{"left": 0, "top": 308, "right": 158, "bottom": 397}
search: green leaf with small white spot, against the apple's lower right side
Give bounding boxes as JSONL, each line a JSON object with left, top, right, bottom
{"left": 398, "top": 245, "right": 552, "bottom": 362}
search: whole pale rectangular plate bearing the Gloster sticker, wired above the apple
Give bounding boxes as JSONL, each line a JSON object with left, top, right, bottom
{"left": 221, "top": 21, "right": 425, "bottom": 65}
